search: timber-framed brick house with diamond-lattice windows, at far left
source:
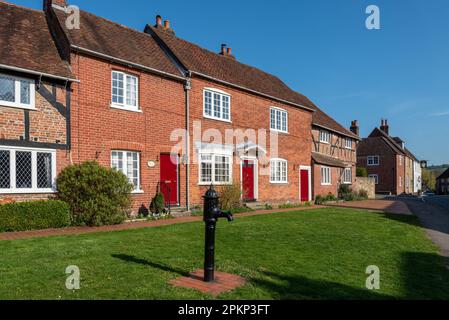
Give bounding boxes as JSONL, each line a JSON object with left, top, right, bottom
{"left": 0, "top": 2, "right": 76, "bottom": 201}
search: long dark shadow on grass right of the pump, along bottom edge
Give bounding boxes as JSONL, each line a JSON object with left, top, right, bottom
{"left": 251, "top": 272, "right": 395, "bottom": 300}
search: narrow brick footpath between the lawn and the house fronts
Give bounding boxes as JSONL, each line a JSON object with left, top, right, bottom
{"left": 0, "top": 206, "right": 325, "bottom": 241}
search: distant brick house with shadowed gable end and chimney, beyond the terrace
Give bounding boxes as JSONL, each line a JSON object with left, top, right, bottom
{"left": 357, "top": 120, "right": 422, "bottom": 194}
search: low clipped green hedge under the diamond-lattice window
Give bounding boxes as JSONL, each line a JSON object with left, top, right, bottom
{"left": 0, "top": 200, "right": 70, "bottom": 232}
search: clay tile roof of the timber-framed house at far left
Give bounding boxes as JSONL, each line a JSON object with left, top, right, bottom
{"left": 0, "top": 2, "right": 74, "bottom": 79}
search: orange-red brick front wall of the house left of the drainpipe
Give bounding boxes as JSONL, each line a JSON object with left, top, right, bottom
{"left": 71, "top": 54, "right": 186, "bottom": 209}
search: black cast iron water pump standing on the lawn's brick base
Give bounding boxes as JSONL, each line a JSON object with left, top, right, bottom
{"left": 203, "top": 185, "right": 234, "bottom": 282}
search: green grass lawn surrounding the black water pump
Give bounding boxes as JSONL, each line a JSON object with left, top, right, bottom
{"left": 0, "top": 208, "right": 449, "bottom": 299}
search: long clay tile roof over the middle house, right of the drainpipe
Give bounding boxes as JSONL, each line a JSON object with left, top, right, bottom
{"left": 147, "top": 25, "right": 313, "bottom": 109}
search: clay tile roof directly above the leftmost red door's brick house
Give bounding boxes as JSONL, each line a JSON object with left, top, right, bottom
{"left": 53, "top": 9, "right": 182, "bottom": 77}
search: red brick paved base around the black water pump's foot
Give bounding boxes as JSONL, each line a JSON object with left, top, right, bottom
{"left": 170, "top": 269, "right": 246, "bottom": 297}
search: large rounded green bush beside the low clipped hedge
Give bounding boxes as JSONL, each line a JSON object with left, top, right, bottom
{"left": 57, "top": 161, "right": 133, "bottom": 226}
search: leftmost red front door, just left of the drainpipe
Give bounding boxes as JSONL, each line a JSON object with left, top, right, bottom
{"left": 160, "top": 154, "right": 179, "bottom": 206}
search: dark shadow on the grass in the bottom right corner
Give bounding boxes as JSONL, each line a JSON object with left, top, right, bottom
{"left": 401, "top": 252, "right": 449, "bottom": 300}
